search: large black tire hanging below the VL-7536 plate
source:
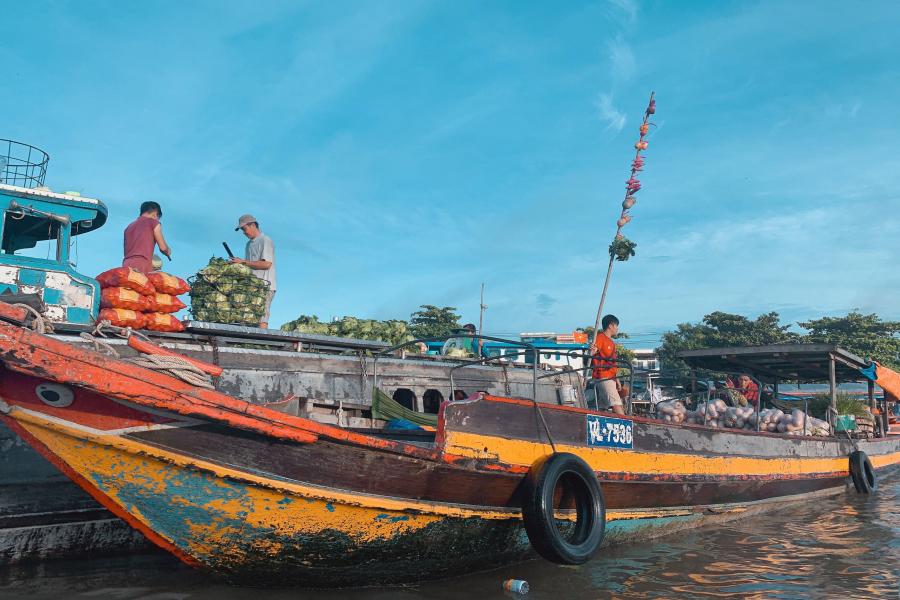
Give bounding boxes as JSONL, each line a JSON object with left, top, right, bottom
{"left": 522, "top": 452, "right": 606, "bottom": 565}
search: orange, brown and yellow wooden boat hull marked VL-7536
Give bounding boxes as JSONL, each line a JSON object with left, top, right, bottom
{"left": 0, "top": 304, "right": 900, "bottom": 586}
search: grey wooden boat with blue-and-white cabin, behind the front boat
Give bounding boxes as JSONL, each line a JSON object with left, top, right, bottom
{"left": 0, "top": 168, "right": 592, "bottom": 563}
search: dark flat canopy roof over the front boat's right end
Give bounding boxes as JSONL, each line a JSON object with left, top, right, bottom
{"left": 677, "top": 344, "right": 870, "bottom": 381}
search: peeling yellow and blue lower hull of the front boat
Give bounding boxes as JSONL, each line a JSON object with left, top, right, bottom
{"left": 8, "top": 408, "right": 856, "bottom": 586}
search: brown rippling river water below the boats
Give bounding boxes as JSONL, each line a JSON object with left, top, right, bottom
{"left": 0, "top": 474, "right": 900, "bottom": 600}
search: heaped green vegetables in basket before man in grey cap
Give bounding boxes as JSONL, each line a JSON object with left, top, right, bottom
{"left": 188, "top": 257, "right": 269, "bottom": 325}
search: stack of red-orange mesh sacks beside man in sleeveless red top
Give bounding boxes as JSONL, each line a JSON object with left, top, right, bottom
{"left": 97, "top": 267, "right": 191, "bottom": 331}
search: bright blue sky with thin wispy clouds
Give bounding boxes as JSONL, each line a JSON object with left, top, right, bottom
{"left": 0, "top": 0, "right": 900, "bottom": 346}
